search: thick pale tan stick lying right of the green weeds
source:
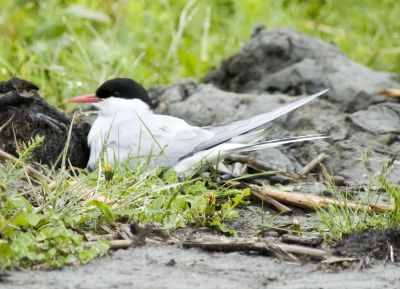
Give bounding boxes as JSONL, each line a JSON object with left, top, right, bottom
{"left": 249, "top": 185, "right": 394, "bottom": 213}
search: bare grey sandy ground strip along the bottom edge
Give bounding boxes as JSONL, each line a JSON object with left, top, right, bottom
{"left": 0, "top": 245, "right": 400, "bottom": 289}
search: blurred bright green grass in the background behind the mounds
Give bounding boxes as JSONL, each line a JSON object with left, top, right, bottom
{"left": 0, "top": 0, "right": 400, "bottom": 107}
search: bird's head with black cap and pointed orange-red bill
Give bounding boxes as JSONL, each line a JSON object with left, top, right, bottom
{"left": 68, "top": 78, "right": 151, "bottom": 107}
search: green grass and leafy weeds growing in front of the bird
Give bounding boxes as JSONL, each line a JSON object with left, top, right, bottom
{"left": 0, "top": 137, "right": 250, "bottom": 269}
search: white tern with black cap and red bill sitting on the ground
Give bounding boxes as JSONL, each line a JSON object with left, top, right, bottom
{"left": 69, "top": 78, "right": 328, "bottom": 175}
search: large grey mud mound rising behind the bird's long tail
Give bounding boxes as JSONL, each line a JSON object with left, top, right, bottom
{"left": 204, "top": 29, "right": 399, "bottom": 111}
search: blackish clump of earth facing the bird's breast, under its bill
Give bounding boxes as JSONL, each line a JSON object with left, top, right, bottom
{"left": 0, "top": 78, "right": 89, "bottom": 168}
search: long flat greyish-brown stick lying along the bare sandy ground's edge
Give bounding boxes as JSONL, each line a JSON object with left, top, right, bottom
{"left": 182, "top": 241, "right": 329, "bottom": 260}
